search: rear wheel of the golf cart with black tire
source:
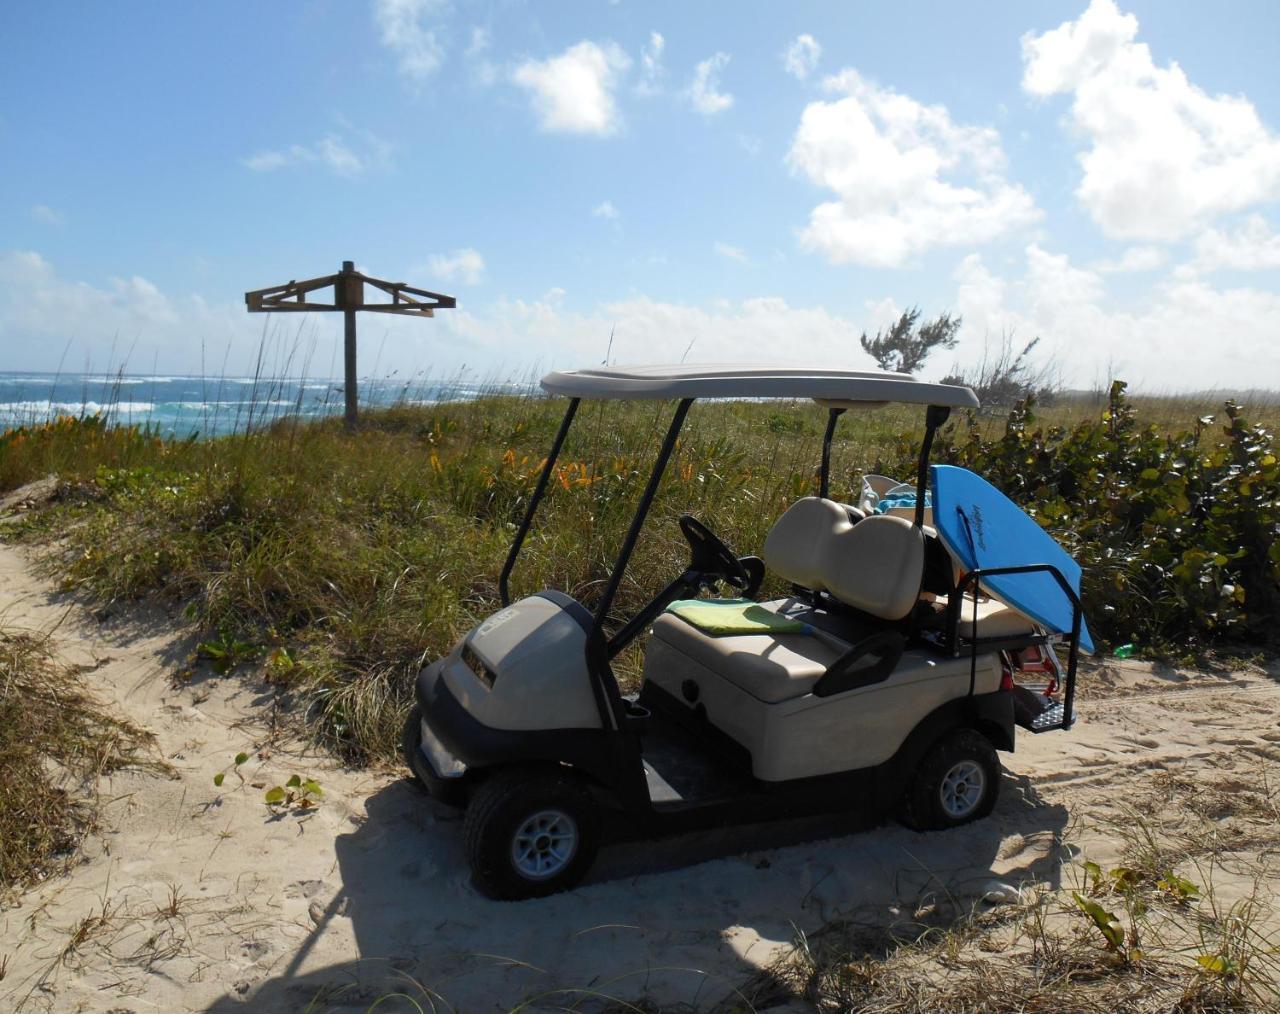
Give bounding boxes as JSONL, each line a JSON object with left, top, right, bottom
{"left": 899, "top": 728, "right": 1000, "bottom": 831}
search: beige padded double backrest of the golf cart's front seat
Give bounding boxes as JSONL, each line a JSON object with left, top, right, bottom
{"left": 762, "top": 497, "right": 924, "bottom": 620}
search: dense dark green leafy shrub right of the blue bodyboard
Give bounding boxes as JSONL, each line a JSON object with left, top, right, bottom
{"left": 878, "top": 382, "right": 1280, "bottom": 649}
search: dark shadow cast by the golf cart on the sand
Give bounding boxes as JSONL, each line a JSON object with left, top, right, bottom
{"left": 211, "top": 773, "right": 1068, "bottom": 1011}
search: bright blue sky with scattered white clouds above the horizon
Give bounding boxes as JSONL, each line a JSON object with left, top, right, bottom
{"left": 0, "top": 0, "right": 1280, "bottom": 389}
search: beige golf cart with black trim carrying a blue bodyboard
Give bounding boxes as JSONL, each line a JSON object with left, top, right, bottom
{"left": 403, "top": 365, "right": 1092, "bottom": 899}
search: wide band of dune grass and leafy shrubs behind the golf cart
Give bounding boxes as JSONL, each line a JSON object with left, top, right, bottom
{"left": 0, "top": 384, "right": 1280, "bottom": 759}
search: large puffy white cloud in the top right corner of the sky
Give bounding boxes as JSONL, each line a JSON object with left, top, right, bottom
{"left": 1023, "top": 0, "right": 1280, "bottom": 241}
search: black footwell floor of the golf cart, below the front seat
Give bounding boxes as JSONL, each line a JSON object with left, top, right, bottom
{"left": 641, "top": 716, "right": 754, "bottom": 809}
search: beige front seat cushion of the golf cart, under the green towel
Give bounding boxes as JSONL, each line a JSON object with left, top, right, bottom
{"left": 653, "top": 599, "right": 849, "bottom": 704}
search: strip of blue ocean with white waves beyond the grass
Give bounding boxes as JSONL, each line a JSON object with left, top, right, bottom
{"left": 0, "top": 373, "right": 509, "bottom": 439}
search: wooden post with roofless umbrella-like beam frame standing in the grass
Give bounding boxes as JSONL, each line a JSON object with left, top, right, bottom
{"left": 244, "top": 261, "right": 458, "bottom": 429}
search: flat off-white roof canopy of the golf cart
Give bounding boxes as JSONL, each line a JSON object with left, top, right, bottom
{"left": 541, "top": 364, "right": 978, "bottom": 408}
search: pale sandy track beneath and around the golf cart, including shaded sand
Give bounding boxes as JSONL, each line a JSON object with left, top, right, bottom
{"left": 0, "top": 545, "right": 1280, "bottom": 1011}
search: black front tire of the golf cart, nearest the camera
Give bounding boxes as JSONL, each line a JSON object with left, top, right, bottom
{"left": 463, "top": 771, "right": 600, "bottom": 901}
